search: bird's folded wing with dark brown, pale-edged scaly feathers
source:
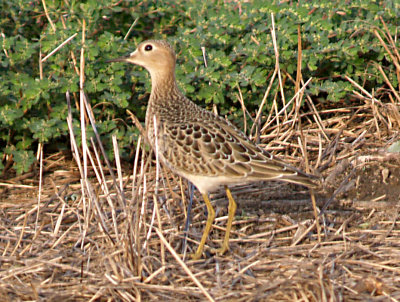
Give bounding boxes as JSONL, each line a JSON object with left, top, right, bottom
{"left": 160, "top": 115, "right": 314, "bottom": 186}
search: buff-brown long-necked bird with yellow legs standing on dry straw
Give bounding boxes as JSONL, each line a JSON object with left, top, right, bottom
{"left": 108, "top": 40, "right": 316, "bottom": 259}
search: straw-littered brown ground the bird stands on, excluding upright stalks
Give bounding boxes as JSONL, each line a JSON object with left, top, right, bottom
{"left": 0, "top": 149, "right": 400, "bottom": 301}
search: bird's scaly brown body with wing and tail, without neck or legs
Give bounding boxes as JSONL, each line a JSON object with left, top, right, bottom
{"left": 147, "top": 96, "right": 315, "bottom": 191}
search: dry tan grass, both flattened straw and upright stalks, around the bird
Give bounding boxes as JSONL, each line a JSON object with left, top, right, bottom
{"left": 0, "top": 14, "right": 400, "bottom": 301}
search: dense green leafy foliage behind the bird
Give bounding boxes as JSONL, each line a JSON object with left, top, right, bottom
{"left": 0, "top": 0, "right": 400, "bottom": 173}
